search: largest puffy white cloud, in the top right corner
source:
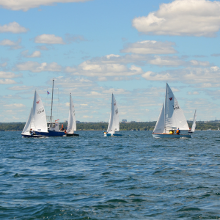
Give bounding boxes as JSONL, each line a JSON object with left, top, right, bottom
{"left": 133, "top": 0, "right": 220, "bottom": 37}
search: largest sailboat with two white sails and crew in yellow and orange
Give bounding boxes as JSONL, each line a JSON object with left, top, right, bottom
{"left": 152, "top": 84, "right": 191, "bottom": 138}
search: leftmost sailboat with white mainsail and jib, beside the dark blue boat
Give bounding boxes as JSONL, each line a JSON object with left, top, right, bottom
{"left": 21, "top": 91, "right": 47, "bottom": 137}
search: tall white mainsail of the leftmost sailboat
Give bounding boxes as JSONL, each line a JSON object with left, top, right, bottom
{"left": 33, "top": 91, "right": 47, "bottom": 132}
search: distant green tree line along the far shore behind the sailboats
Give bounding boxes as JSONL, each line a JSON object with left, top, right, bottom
{"left": 0, "top": 121, "right": 220, "bottom": 131}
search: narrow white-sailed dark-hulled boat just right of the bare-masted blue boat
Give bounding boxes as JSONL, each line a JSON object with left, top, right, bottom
{"left": 66, "top": 93, "right": 79, "bottom": 136}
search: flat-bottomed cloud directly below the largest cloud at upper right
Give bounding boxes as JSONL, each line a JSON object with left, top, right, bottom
{"left": 121, "top": 40, "right": 176, "bottom": 54}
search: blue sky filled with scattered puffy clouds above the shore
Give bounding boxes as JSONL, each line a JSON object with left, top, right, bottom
{"left": 0, "top": 0, "right": 220, "bottom": 122}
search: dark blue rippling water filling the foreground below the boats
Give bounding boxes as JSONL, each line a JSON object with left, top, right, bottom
{"left": 0, "top": 131, "right": 220, "bottom": 220}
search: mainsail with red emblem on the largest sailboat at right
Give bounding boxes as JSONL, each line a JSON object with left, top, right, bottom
{"left": 165, "top": 84, "right": 189, "bottom": 133}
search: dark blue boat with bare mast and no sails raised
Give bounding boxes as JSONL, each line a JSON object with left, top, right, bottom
{"left": 35, "top": 80, "right": 65, "bottom": 136}
